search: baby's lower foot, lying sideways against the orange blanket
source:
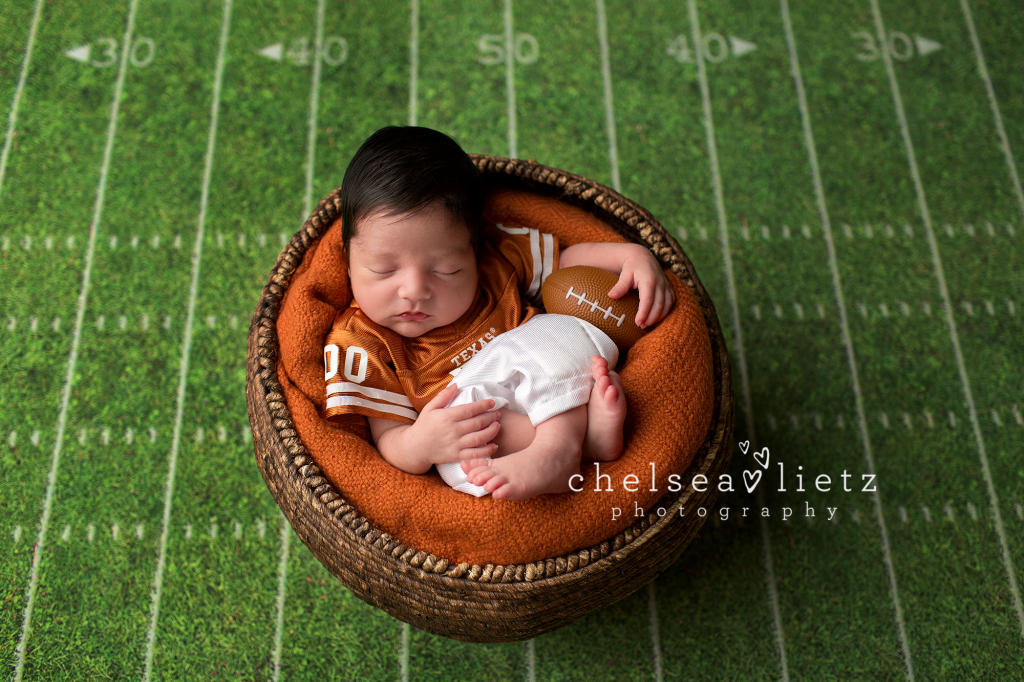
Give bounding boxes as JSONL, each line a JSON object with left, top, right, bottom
{"left": 466, "top": 445, "right": 580, "bottom": 500}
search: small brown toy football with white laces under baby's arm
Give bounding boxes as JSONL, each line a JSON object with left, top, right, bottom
{"left": 541, "top": 265, "right": 644, "bottom": 354}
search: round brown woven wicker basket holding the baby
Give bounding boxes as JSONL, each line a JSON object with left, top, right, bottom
{"left": 246, "top": 156, "right": 733, "bottom": 642}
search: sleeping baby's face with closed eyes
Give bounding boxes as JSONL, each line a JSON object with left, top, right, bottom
{"left": 348, "top": 205, "right": 478, "bottom": 338}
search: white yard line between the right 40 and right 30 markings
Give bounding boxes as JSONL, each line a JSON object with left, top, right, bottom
{"left": 780, "top": 0, "right": 913, "bottom": 671}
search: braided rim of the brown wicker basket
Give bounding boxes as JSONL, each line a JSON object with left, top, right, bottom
{"left": 246, "top": 155, "right": 733, "bottom": 594}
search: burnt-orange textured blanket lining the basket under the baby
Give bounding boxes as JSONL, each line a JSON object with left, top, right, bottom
{"left": 278, "top": 189, "right": 714, "bottom": 565}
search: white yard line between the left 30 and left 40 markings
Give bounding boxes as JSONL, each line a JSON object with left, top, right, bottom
{"left": 141, "top": 0, "right": 231, "bottom": 682}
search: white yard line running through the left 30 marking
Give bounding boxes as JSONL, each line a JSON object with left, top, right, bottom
{"left": 14, "top": 0, "right": 138, "bottom": 682}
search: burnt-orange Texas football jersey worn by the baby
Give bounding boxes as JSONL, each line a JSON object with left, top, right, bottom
{"left": 324, "top": 224, "right": 559, "bottom": 424}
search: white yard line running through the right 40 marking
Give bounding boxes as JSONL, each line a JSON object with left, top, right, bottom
{"left": 686, "top": 0, "right": 790, "bottom": 682}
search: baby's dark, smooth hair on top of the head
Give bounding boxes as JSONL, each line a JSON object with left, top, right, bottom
{"left": 341, "top": 126, "right": 484, "bottom": 257}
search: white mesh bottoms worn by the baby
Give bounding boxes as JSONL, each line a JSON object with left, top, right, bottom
{"left": 436, "top": 314, "right": 618, "bottom": 497}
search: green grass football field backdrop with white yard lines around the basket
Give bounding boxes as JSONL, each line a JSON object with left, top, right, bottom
{"left": 0, "top": 0, "right": 1024, "bottom": 681}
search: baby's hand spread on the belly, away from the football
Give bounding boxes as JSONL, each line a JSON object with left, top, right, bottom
{"left": 408, "top": 382, "right": 501, "bottom": 464}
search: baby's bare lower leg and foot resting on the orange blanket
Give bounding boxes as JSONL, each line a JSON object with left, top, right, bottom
{"left": 467, "top": 406, "right": 587, "bottom": 500}
